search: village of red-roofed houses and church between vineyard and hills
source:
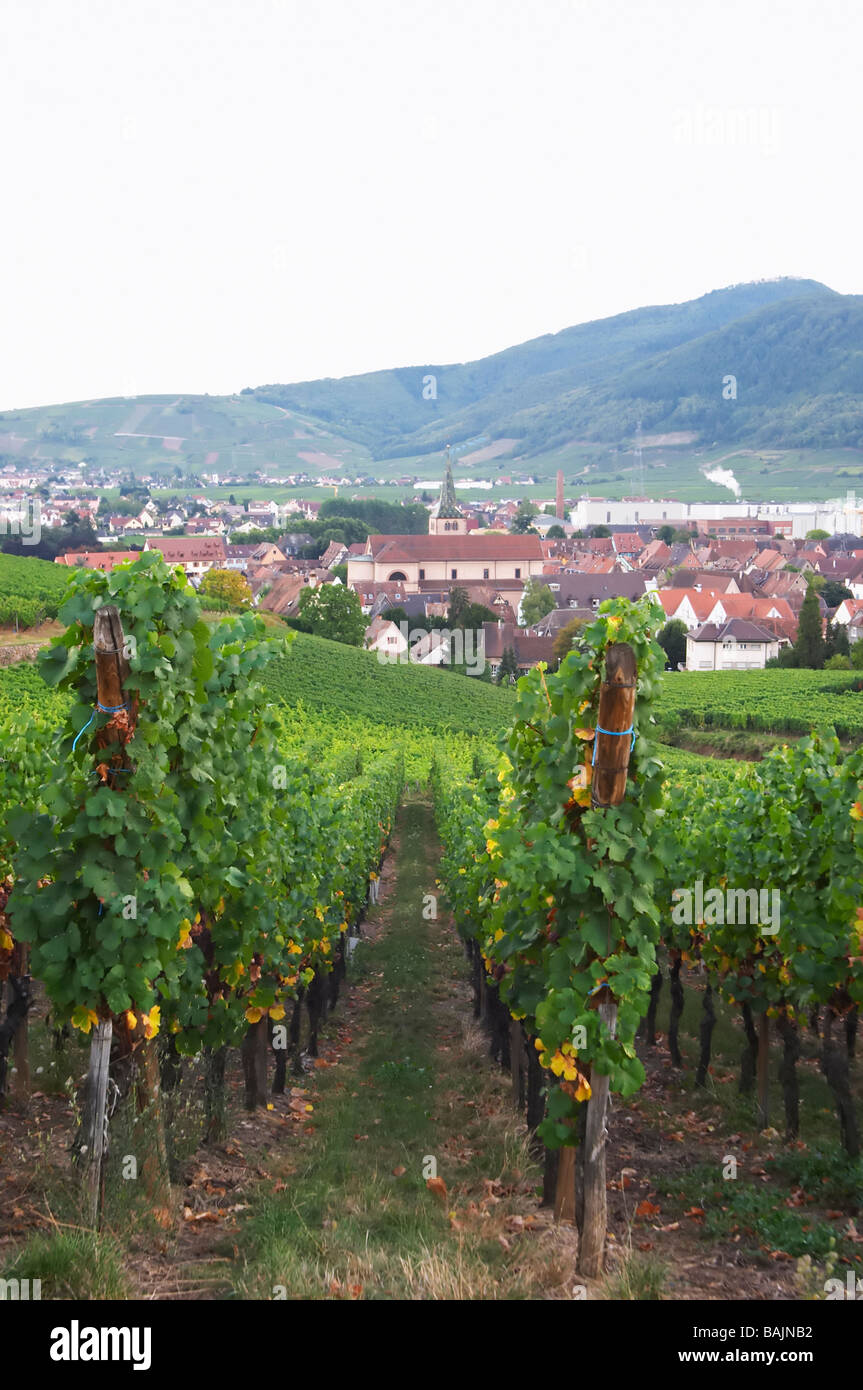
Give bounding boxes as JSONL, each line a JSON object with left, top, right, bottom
{"left": 0, "top": 452, "right": 863, "bottom": 680}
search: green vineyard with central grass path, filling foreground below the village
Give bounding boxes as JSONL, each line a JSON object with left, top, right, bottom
{"left": 0, "top": 555, "right": 863, "bottom": 1298}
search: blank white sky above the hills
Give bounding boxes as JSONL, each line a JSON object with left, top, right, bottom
{"left": 0, "top": 0, "right": 863, "bottom": 409}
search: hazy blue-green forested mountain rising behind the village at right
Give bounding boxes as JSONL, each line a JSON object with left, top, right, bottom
{"left": 241, "top": 279, "right": 863, "bottom": 459}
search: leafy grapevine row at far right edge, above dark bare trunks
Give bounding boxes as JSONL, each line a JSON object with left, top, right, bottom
{"left": 663, "top": 734, "right": 863, "bottom": 1155}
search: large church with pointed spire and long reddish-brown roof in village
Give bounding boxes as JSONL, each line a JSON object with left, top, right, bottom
{"left": 347, "top": 452, "right": 545, "bottom": 594}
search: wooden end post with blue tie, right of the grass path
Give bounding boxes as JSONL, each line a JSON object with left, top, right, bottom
{"left": 578, "top": 642, "right": 638, "bottom": 1279}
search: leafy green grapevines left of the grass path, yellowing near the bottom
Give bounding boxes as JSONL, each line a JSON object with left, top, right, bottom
{"left": 0, "top": 555, "right": 403, "bottom": 1212}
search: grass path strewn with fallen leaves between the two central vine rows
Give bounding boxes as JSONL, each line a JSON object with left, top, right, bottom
{"left": 233, "top": 801, "right": 575, "bottom": 1300}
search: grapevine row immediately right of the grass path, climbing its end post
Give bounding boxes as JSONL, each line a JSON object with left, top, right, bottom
{"left": 434, "top": 600, "right": 664, "bottom": 1273}
